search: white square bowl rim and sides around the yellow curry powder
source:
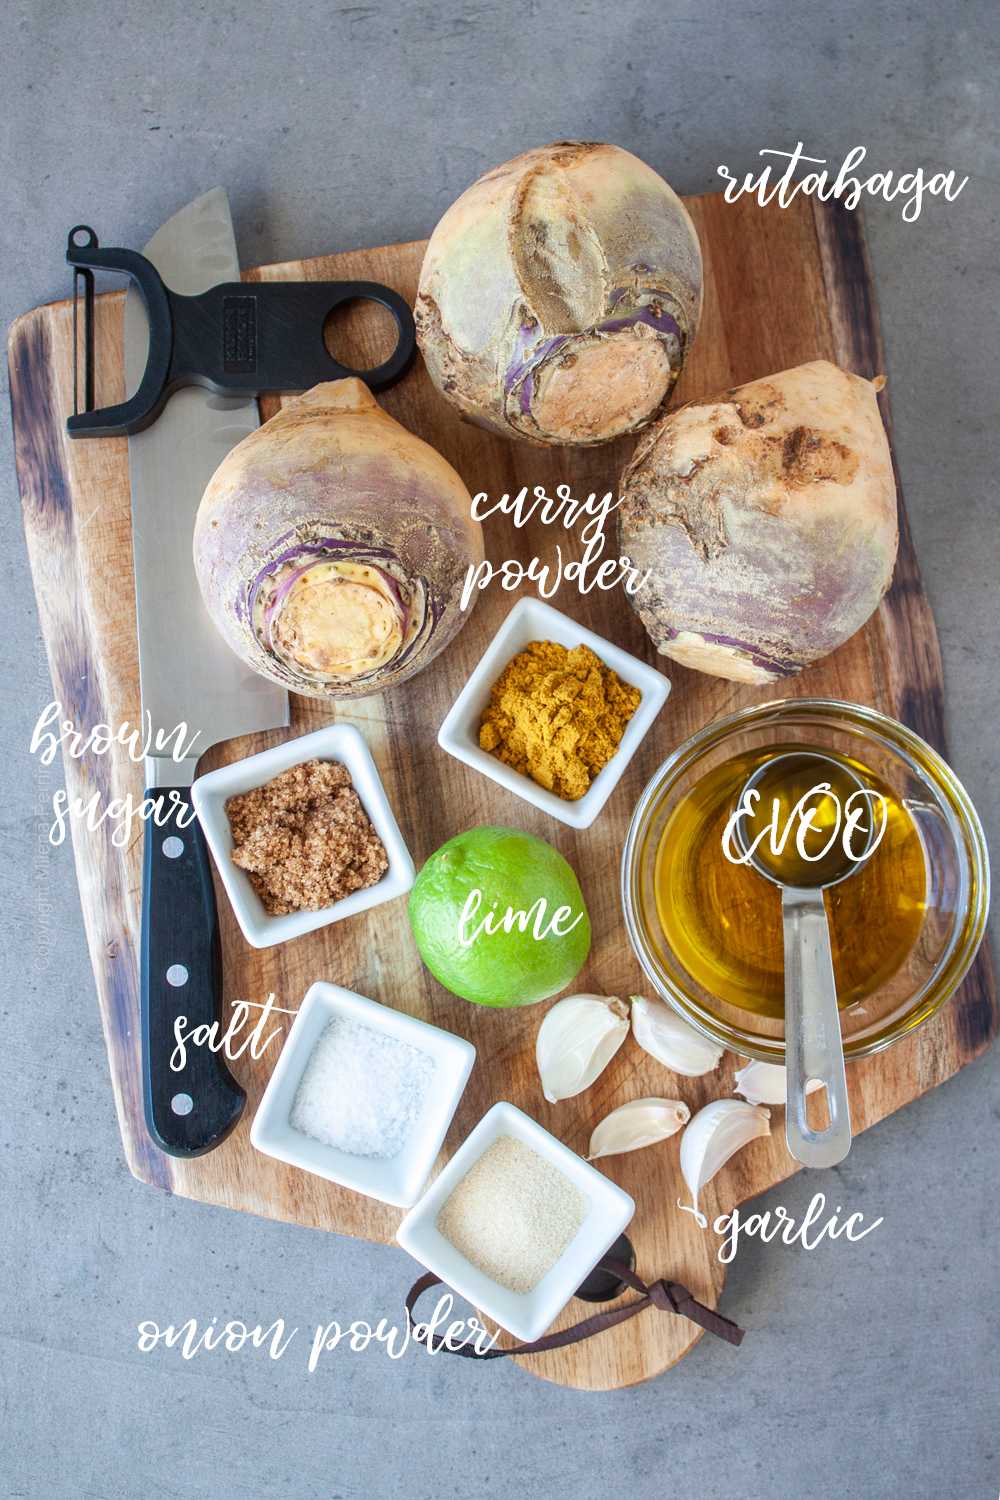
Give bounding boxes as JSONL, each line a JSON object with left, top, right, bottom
{"left": 438, "top": 597, "right": 670, "bottom": 828}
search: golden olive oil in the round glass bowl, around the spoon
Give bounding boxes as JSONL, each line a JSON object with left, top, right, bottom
{"left": 654, "top": 744, "right": 928, "bottom": 1017}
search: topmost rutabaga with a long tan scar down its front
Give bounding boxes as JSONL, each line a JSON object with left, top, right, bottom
{"left": 414, "top": 141, "right": 702, "bottom": 444}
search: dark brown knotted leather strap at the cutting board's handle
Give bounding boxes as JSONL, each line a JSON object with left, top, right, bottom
{"left": 406, "top": 1259, "right": 744, "bottom": 1359}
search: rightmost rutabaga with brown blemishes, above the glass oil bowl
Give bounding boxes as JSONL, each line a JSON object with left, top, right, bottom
{"left": 618, "top": 360, "right": 898, "bottom": 684}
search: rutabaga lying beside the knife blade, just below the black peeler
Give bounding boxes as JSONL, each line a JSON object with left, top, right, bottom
{"left": 195, "top": 380, "right": 483, "bottom": 699}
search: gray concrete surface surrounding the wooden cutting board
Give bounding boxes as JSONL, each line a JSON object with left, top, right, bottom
{"left": 0, "top": 0, "right": 1000, "bottom": 1500}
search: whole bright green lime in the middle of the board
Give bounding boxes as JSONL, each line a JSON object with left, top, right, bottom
{"left": 409, "top": 828, "right": 591, "bottom": 1005}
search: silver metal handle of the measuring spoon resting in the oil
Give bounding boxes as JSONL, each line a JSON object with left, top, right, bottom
{"left": 781, "top": 887, "right": 852, "bottom": 1167}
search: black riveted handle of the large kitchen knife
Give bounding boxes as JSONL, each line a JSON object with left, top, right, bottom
{"left": 139, "top": 786, "right": 246, "bottom": 1157}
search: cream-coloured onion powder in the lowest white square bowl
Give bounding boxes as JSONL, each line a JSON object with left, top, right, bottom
{"left": 436, "top": 1136, "right": 588, "bottom": 1292}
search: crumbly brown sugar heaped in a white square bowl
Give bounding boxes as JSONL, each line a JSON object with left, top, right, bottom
{"left": 226, "top": 761, "right": 388, "bottom": 917}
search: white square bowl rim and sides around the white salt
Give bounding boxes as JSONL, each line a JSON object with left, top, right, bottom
{"left": 250, "top": 980, "right": 475, "bottom": 1208}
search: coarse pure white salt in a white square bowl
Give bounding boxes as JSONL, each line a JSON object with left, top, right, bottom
{"left": 288, "top": 1017, "right": 435, "bottom": 1160}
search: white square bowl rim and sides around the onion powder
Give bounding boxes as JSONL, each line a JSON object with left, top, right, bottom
{"left": 396, "top": 1103, "right": 636, "bottom": 1343}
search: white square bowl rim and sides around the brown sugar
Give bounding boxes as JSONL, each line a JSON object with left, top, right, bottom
{"left": 190, "top": 725, "right": 415, "bottom": 948}
